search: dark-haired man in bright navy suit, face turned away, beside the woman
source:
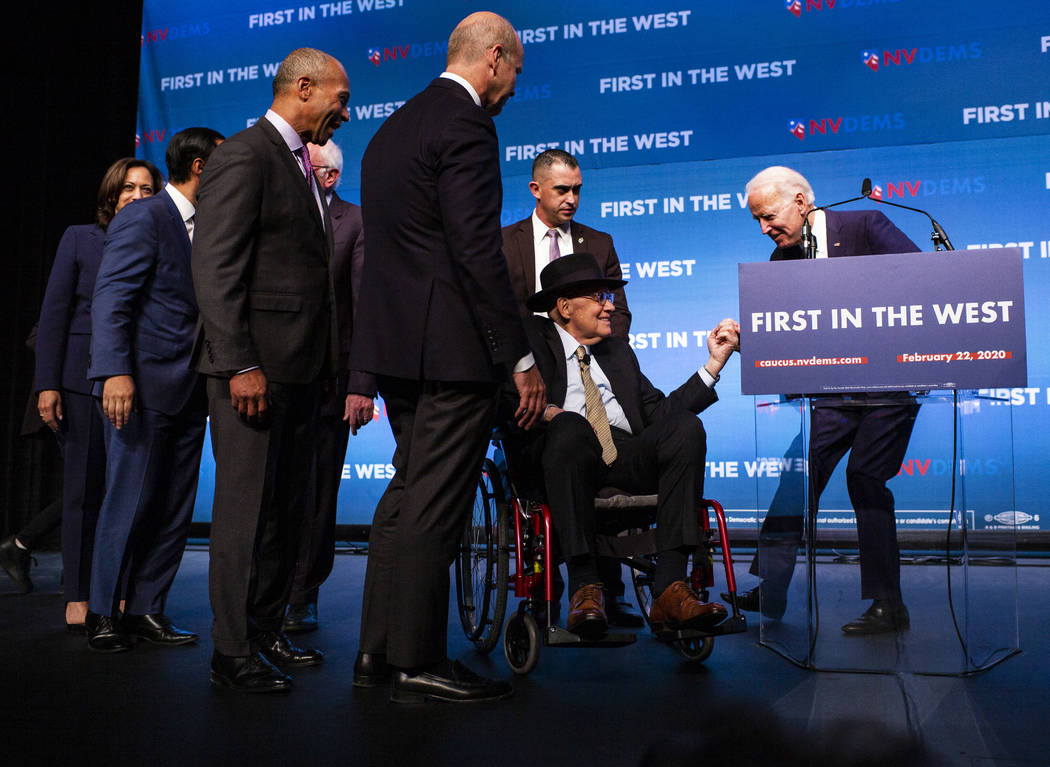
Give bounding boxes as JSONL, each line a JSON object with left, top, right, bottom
{"left": 86, "top": 128, "right": 224, "bottom": 652}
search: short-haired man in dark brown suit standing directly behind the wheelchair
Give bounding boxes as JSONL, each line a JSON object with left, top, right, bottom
{"left": 503, "top": 149, "right": 645, "bottom": 628}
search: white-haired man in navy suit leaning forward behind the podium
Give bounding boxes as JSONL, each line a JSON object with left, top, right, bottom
{"left": 740, "top": 166, "right": 919, "bottom": 636}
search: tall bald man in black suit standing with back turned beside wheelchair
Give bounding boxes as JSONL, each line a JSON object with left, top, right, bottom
{"left": 350, "top": 13, "right": 544, "bottom": 702}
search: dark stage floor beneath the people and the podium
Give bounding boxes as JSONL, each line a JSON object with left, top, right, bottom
{"left": 0, "top": 548, "right": 1050, "bottom": 767}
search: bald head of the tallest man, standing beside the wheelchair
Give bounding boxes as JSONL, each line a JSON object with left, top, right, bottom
{"left": 445, "top": 11, "right": 525, "bottom": 115}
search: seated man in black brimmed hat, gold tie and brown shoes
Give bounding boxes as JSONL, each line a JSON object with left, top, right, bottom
{"left": 506, "top": 253, "right": 740, "bottom": 639}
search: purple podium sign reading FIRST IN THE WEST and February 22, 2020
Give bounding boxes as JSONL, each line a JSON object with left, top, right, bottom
{"left": 738, "top": 248, "right": 1028, "bottom": 394}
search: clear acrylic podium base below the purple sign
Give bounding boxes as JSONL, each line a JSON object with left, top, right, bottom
{"left": 741, "top": 392, "right": 1019, "bottom": 675}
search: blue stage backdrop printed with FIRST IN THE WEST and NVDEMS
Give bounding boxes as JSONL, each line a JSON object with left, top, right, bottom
{"left": 138, "top": 0, "right": 1050, "bottom": 528}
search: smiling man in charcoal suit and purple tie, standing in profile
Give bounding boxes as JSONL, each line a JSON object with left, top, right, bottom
{"left": 192, "top": 48, "right": 350, "bottom": 692}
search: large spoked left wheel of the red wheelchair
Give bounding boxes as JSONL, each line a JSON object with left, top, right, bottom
{"left": 456, "top": 458, "right": 509, "bottom": 654}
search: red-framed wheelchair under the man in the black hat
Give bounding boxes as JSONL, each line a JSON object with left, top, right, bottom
{"left": 455, "top": 433, "right": 748, "bottom": 675}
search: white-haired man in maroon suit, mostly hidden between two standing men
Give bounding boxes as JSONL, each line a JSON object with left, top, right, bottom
{"left": 284, "top": 141, "right": 376, "bottom": 634}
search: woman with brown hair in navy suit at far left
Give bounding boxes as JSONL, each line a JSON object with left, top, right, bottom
{"left": 36, "top": 158, "right": 164, "bottom": 630}
